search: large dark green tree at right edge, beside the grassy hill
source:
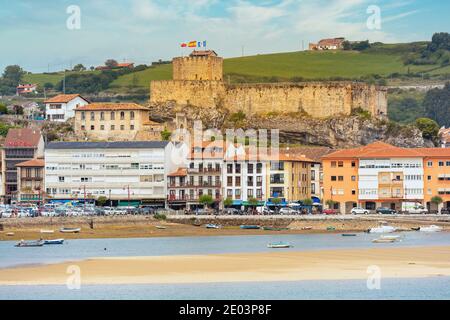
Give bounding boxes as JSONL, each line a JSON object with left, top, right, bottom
{"left": 423, "top": 83, "right": 450, "bottom": 127}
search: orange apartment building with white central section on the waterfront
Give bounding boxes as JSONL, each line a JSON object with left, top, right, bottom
{"left": 322, "top": 142, "right": 450, "bottom": 213}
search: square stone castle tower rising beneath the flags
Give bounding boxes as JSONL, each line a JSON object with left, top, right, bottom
{"left": 172, "top": 50, "right": 223, "bottom": 81}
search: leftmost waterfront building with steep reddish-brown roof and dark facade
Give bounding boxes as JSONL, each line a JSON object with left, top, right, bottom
{"left": 1, "top": 128, "right": 44, "bottom": 204}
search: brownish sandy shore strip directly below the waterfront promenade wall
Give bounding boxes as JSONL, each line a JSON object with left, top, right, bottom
{"left": 0, "top": 216, "right": 450, "bottom": 241}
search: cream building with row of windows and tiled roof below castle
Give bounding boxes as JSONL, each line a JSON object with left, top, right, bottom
{"left": 75, "top": 103, "right": 164, "bottom": 141}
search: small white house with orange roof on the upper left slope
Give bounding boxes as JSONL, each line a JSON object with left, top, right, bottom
{"left": 44, "top": 94, "right": 89, "bottom": 122}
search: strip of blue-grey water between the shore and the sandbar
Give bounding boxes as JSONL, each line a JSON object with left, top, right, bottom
{"left": 0, "top": 232, "right": 450, "bottom": 268}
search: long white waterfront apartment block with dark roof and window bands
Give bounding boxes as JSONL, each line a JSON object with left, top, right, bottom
{"left": 45, "top": 141, "right": 174, "bottom": 206}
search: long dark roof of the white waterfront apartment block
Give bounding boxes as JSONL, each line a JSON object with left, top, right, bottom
{"left": 46, "top": 141, "right": 169, "bottom": 149}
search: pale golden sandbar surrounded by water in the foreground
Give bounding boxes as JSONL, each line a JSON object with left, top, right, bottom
{"left": 0, "top": 246, "right": 450, "bottom": 285}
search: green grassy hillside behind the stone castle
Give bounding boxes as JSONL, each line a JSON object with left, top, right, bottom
{"left": 25, "top": 42, "right": 450, "bottom": 93}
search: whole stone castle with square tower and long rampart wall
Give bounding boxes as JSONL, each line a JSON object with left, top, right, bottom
{"left": 150, "top": 51, "right": 387, "bottom": 118}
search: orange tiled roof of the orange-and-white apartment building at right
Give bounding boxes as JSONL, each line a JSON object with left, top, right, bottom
{"left": 322, "top": 141, "right": 450, "bottom": 159}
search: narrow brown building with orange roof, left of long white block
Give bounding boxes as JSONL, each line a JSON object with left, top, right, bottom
{"left": 16, "top": 158, "right": 45, "bottom": 203}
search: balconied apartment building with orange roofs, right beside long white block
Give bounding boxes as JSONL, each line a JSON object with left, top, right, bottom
{"left": 167, "top": 142, "right": 224, "bottom": 210}
